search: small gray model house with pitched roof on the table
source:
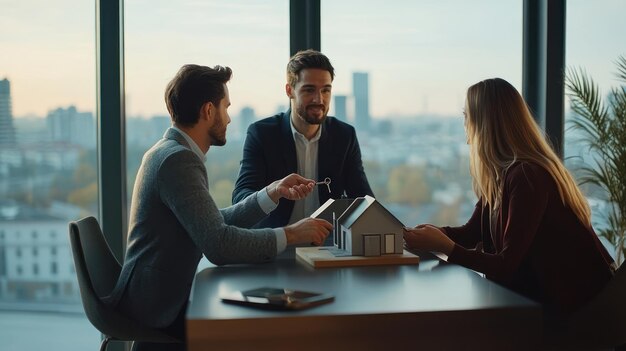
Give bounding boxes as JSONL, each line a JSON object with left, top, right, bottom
{"left": 311, "top": 196, "right": 404, "bottom": 256}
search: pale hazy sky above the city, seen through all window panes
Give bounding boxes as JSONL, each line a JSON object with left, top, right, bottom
{"left": 0, "top": 0, "right": 626, "bottom": 118}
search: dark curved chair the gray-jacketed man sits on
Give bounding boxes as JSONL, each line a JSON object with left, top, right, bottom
{"left": 69, "top": 217, "right": 181, "bottom": 351}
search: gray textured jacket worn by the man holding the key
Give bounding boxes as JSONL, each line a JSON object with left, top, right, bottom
{"left": 104, "top": 128, "right": 277, "bottom": 328}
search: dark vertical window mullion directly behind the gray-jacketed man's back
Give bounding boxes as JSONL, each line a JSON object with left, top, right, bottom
{"left": 96, "top": 0, "right": 127, "bottom": 262}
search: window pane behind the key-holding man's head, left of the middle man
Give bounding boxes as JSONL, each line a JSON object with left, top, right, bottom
{"left": 124, "top": 0, "right": 289, "bottom": 207}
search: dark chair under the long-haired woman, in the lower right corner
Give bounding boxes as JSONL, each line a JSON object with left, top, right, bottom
{"left": 546, "top": 264, "right": 626, "bottom": 350}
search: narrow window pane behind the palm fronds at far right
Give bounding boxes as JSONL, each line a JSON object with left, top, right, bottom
{"left": 564, "top": 0, "right": 626, "bottom": 258}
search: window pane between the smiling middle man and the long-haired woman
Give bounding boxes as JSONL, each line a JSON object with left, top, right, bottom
{"left": 321, "top": 0, "right": 522, "bottom": 225}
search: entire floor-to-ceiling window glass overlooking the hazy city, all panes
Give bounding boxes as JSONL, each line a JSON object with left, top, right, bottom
{"left": 0, "top": 0, "right": 626, "bottom": 350}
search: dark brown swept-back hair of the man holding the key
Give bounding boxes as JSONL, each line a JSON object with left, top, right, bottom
{"left": 165, "top": 65, "right": 233, "bottom": 126}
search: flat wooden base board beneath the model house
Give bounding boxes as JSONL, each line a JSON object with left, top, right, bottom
{"left": 296, "top": 247, "right": 420, "bottom": 268}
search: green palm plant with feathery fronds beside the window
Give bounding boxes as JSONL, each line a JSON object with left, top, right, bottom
{"left": 565, "top": 56, "right": 626, "bottom": 265}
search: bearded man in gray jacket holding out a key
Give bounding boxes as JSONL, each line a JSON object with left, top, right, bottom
{"left": 105, "top": 65, "right": 331, "bottom": 349}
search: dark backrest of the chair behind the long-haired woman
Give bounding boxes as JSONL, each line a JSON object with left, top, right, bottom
{"left": 569, "top": 264, "right": 626, "bottom": 348}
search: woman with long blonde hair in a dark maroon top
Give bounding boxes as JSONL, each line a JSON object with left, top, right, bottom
{"left": 404, "top": 78, "right": 613, "bottom": 312}
